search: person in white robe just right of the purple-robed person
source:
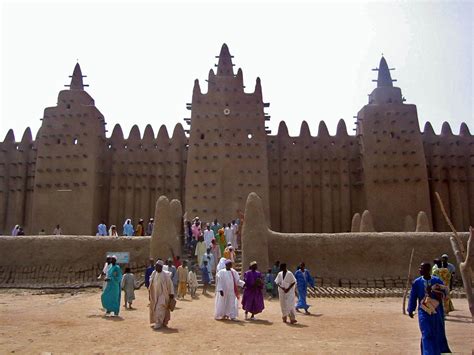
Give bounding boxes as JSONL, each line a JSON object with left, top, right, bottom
{"left": 274, "top": 264, "right": 297, "bottom": 324}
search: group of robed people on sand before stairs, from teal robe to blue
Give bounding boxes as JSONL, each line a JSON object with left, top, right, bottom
{"left": 99, "top": 255, "right": 314, "bottom": 329}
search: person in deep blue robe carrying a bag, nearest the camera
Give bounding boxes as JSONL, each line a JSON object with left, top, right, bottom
{"left": 408, "top": 263, "right": 451, "bottom": 355}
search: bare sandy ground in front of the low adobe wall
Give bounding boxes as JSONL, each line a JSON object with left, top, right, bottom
{"left": 0, "top": 289, "right": 474, "bottom": 354}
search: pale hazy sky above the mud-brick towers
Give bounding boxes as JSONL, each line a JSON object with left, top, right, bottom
{"left": 0, "top": 1, "right": 474, "bottom": 140}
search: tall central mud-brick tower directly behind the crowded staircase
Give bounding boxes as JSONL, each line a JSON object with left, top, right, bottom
{"left": 185, "top": 44, "right": 269, "bottom": 222}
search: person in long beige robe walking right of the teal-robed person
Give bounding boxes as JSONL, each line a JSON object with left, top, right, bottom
{"left": 148, "top": 260, "right": 174, "bottom": 329}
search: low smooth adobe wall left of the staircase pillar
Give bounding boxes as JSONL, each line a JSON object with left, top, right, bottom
{"left": 0, "top": 235, "right": 150, "bottom": 288}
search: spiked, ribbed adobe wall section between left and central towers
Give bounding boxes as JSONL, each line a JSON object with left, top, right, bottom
{"left": 106, "top": 124, "right": 188, "bottom": 233}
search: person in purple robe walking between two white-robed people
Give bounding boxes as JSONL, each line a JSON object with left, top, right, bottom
{"left": 242, "top": 261, "right": 265, "bottom": 320}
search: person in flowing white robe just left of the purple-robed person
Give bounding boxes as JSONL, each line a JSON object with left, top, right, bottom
{"left": 214, "top": 260, "right": 245, "bottom": 320}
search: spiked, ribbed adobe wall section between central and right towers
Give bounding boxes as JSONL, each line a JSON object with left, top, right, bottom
{"left": 267, "top": 120, "right": 365, "bottom": 233}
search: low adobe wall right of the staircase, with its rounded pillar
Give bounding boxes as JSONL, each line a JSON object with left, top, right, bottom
{"left": 242, "top": 193, "right": 474, "bottom": 285}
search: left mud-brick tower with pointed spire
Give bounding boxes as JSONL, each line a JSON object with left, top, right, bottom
{"left": 32, "top": 64, "right": 106, "bottom": 235}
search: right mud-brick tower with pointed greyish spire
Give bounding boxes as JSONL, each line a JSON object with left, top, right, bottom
{"left": 357, "top": 57, "right": 431, "bottom": 231}
